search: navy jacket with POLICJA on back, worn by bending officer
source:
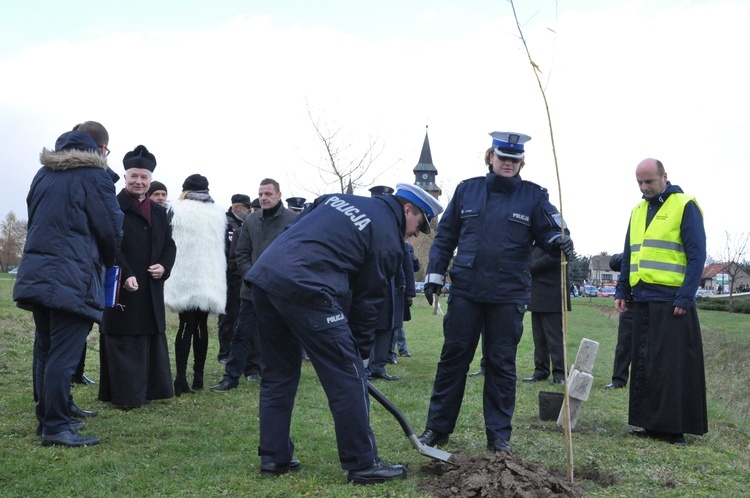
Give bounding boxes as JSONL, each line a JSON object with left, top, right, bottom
{"left": 245, "top": 194, "right": 406, "bottom": 337}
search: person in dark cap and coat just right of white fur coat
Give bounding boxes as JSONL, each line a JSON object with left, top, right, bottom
{"left": 218, "top": 194, "right": 252, "bottom": 363}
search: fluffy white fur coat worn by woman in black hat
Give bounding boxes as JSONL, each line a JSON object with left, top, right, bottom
{"left": 164, "top": 199, "right": 227, "bottom": 314}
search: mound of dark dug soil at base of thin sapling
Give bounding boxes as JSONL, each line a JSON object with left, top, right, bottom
{"left": 421, "top": 453, "right": 583, "bottom": 498}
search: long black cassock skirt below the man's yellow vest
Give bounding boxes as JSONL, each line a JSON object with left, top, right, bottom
{"left": 628, "top": 302, "right": 708, "bottom": 435}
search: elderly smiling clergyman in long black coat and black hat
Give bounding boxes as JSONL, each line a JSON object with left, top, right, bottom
{"left": 99, "top": 145, "right": 175, "bottom": 410}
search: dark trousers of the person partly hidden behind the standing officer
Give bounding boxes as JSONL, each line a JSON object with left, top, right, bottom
{"left": 531, "top": 311, "right": 565, "bottom": 379}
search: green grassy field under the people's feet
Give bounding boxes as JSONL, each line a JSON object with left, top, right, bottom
{"left": 0, "top": 275, "right": 750, "bottom": 497}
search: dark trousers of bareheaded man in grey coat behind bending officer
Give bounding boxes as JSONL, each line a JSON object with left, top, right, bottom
{"left": 224, "top": 298, "right": 260, "bottom": 386}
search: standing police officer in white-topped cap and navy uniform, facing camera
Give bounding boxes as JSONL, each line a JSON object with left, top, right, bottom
{"left": 419, "top": 132, "right": 573, "bottom": 452}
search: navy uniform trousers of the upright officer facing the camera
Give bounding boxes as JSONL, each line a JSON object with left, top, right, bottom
{"left": 427, "top": 294, "right": 526, "bottom": 441}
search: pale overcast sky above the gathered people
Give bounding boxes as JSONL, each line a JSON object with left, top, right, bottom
{"left": 0, "top": 0, "right": 750, "bottom": 257}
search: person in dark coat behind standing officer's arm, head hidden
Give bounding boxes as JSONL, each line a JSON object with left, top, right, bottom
{"left": 523, "top": 246, "right": 570, "bottom": 384}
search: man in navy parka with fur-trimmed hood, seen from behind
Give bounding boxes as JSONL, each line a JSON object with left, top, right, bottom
{"left": 13, "top": 121, "right": 122, "bottom": 446}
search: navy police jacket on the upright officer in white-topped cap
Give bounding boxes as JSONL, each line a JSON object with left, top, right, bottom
{"left": 427, "top": 173, "right": 568, "bottom": 304}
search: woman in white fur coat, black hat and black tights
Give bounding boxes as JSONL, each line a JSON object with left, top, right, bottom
{"left": 164, "top": 174, "right": 227, "bottom": 396}
